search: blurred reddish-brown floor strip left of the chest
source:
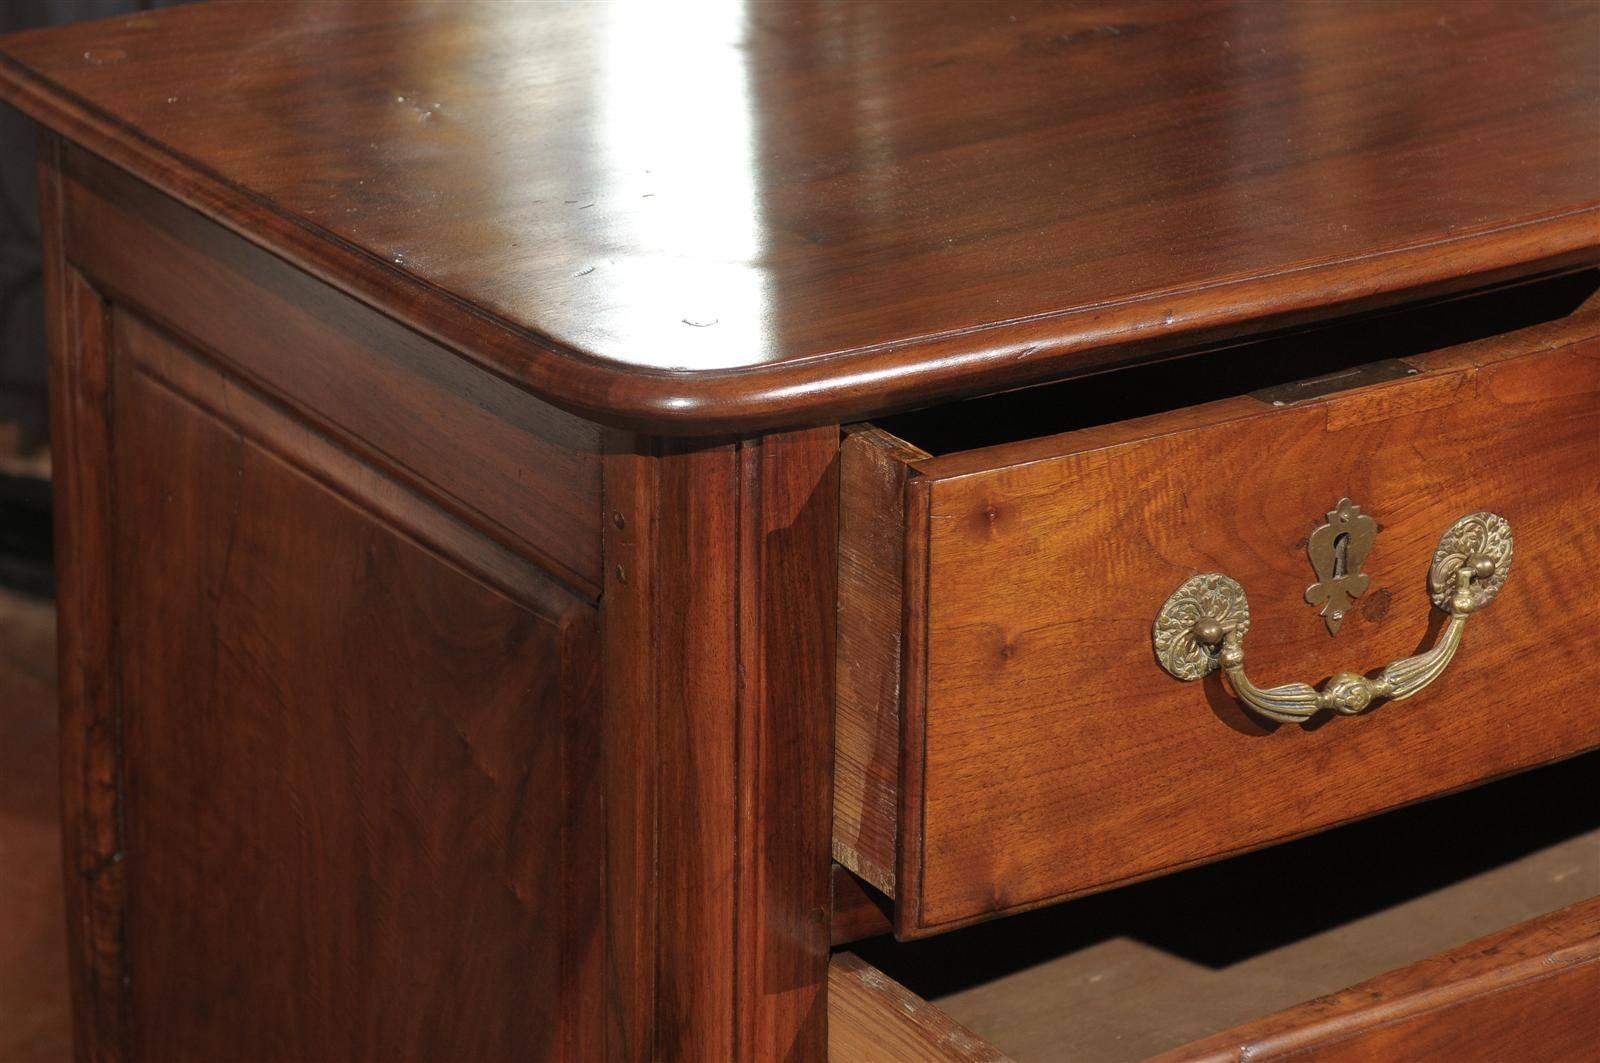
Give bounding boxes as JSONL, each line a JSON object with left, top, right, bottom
{"left": 0, "top": 591, "right": 70, "bottom": 1063}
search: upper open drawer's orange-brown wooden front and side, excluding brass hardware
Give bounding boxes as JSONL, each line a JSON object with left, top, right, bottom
{"left": 835, "top": 328, "right": 1600, "bottom": 937}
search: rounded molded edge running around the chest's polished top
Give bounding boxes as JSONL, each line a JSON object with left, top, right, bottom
{"left": 0, "top": 53, "right": 1600, "bottom": 435}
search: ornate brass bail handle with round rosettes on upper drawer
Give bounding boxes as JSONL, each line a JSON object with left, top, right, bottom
{"left": 1154, "top": 512, "right": 1512, "bottom": 724}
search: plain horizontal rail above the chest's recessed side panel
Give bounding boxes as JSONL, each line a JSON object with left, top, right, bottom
{"left": 62, "top": 140, "right": 600, "bottom": 597}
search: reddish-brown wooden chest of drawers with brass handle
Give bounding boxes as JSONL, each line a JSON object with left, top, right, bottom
{"left": 0, "top": 2, "right": 1600, "bottom": 1060}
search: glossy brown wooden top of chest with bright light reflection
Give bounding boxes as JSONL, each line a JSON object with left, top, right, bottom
{"left": 0, "top": 0, "right": 1600, "bottom": 432}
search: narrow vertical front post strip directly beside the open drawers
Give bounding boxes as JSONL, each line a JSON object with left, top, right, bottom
{"left": 736, "top": 424, "right": 838, "bottom": 1060}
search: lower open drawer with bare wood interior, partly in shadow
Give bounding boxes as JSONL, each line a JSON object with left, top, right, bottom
{"left": 829, "top": 752, "right": 1600, "bottom": 1063}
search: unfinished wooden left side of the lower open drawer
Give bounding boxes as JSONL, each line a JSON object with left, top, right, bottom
{"left": 827, "top": 953, "right": 1010, "bottom": 1063}
